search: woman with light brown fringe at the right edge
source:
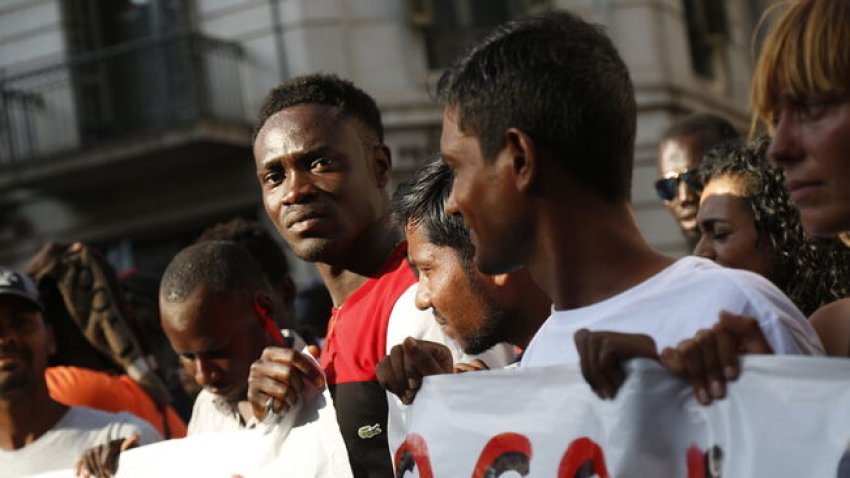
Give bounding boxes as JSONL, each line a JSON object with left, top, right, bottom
{"left": 752, "top": 0, "right": 850, "bottom": 356}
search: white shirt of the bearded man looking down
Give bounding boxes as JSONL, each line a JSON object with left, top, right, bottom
{"left": 386, "top": 284, "right": 516, "bottom": 368}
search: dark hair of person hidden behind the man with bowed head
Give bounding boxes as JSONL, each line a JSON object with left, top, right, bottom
{"left": 195, "top": 217, "right": 289, "bottom": 285}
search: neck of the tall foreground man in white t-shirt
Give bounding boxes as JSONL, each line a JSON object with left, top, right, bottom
{"left": 529, "top": 188, "right": 674, "bottom": 310}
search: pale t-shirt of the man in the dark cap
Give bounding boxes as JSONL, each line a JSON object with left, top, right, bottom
{"left": 0, "top": 407, "right": 162, "bottom": 478}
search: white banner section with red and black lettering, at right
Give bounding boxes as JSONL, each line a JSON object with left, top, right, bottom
{"left": 390, "top": 356, "right": 850, "bottom": 478}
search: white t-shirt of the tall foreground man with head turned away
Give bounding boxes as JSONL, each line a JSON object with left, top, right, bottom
{"left": 521, "top": 256, "right": 824, "bottom": 366}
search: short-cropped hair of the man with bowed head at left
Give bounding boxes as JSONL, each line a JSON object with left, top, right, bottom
{"left": 159, "top": 241, "right": 271, "bottom": 302}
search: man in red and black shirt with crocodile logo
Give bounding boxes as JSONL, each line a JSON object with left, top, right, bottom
{"left": 248, "top": 75, "right": 504, "bottom": 477}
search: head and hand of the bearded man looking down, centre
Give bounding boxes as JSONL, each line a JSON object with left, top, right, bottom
{"left": 377, "top": 158, "right": 552, "bottom": 403}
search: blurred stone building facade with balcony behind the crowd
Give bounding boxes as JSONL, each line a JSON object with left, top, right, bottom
{"left": 0, "top": 0, "right": 767, "bottom": 282}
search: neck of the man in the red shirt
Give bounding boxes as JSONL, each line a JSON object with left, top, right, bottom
{"left": 316, "top": 219, "right": 401, "bottom": 307}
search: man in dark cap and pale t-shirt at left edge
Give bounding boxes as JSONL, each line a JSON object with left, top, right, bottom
{"left": 0, "top": 267, "right": 160, "bottom": 476}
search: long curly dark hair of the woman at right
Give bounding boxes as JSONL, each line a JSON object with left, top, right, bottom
{"left": 700, "top": 136, "right": 850, "bottom": 316}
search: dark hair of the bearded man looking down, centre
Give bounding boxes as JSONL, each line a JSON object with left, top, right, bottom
{"left": 392, "top": 158, "right": 474, "bottom": 267}
